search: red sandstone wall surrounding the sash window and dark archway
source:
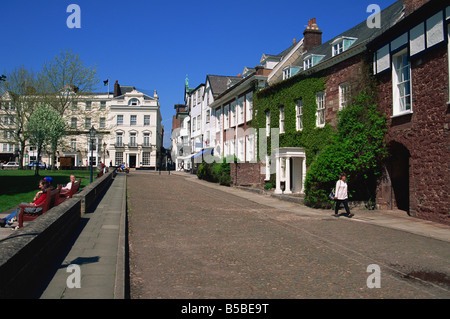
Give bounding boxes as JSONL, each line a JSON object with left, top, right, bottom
{"left": 377, "top": 46, "right": 450, "bottom": 224}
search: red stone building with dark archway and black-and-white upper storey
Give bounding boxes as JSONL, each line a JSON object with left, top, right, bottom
{"left": 370, "top": 0, "right": 450, "bottom": 224}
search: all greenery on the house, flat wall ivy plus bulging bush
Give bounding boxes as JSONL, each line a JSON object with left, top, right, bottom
{"left": 252, "top": 63, "right": 387, "bottom": 207}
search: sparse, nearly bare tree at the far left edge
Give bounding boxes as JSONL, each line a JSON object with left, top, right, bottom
{"left": 0, "top": 66, "right": 42, "bottom": 169}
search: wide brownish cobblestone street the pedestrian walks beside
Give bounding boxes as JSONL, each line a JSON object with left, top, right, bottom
{"left": 128, "top": 172, "right": 450, "bottom": 299}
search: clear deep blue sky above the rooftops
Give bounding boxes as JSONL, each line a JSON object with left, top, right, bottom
{"left": 0, "top": 0, "right": 395, "bottom": 146}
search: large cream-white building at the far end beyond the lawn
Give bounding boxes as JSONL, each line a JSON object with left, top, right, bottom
{"left": 0, "top": 81, "right": 164, "bottom": 169}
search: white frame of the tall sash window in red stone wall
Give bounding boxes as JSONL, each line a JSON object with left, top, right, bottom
{"left": 392, "top": 49, "right": 413, "bottom": 117}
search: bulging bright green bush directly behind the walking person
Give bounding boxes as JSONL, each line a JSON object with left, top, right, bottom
{"left": 305, "top": 91, "right": 387, "bottom": 207}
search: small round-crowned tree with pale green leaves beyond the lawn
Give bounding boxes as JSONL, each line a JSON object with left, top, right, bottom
{"left": 26, "top": 104, "right": 66, "bottom": 175}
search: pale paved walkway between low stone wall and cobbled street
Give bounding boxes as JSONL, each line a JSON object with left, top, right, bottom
{"left": 41, "top": 173, "right": 126, "bottom": 299}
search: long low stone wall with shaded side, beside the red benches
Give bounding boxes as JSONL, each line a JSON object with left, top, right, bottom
{"left": 0, "top": 170, "right": 116, "bottom": 299}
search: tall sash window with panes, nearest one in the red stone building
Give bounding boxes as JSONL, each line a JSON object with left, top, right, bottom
{"left": 392, "top": 50, "right": 411, "bottom": 116}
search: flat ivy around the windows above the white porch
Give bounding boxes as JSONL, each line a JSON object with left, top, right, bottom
{"left": 252, "top": 76, "right": 333, "bottom": 166}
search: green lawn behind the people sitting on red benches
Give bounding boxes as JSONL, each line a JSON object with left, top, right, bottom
{"left": 0, "top": 170, "right": 97, "bottom": 212}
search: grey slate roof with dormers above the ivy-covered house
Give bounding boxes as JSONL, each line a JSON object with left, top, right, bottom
{"left": 304, "top": 0, "right": 404, "bottom": 70}
